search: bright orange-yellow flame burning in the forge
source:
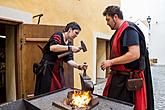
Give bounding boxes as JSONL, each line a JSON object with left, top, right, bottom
{"left": 71, "top": 91, "right": 92, "bottom": 108}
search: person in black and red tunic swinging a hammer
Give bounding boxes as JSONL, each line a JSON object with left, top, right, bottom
{"left": 34, "top": 22, "right": 87, "bottom": 95}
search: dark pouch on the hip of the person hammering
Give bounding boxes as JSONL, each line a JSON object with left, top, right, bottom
{"left": 33, "top": 63, "right": 45, "bottom": 75}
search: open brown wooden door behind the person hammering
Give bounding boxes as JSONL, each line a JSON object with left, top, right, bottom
{"left": 20, "top": 24, "right": 73, "bottom": 98}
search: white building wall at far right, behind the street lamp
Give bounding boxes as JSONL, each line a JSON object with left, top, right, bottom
{"left": 149, "top": 22, "right": 165, "bottom": 65}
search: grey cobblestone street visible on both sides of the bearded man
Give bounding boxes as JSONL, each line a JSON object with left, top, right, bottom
{"left": 94, "top": 65, "right": 165, "bottom": 110}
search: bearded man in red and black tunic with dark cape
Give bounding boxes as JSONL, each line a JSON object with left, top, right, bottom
{"left": 101, "top": 6, "right": 154, "bottom": 110}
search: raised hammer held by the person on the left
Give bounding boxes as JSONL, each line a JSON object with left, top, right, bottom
{"left": 58, "top": 41, "right": 87, "bottom": 58}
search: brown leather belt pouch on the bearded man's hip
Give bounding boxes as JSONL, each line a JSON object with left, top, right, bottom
{"left": 127, "top": 78, "right": 143, "bottom": 91}
